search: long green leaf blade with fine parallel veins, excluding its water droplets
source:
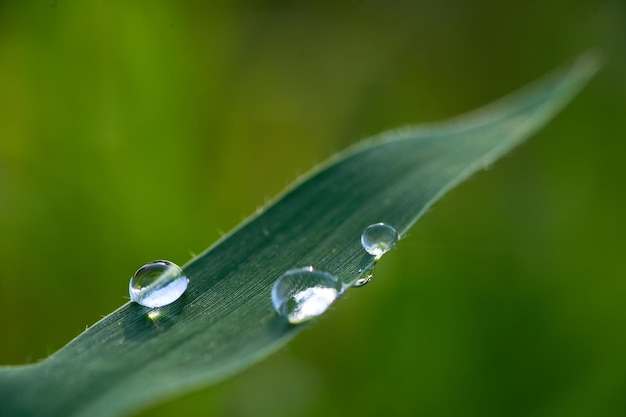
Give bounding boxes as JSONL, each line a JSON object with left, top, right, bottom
{"left": 0, "top": 56, "right": 597, "bottom": 417}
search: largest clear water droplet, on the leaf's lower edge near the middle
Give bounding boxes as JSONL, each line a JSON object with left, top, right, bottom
{"left": 272, "top": 266, "right": 344, "bottom": 324}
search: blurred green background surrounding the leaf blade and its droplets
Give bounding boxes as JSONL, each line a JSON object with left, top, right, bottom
{"left": 0, "top": 0, "right": 626, "bottom": 417}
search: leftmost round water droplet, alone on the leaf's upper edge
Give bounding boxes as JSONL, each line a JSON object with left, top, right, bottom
{"left": 128, "top": 261, "right": 189, "bottom": 307}
